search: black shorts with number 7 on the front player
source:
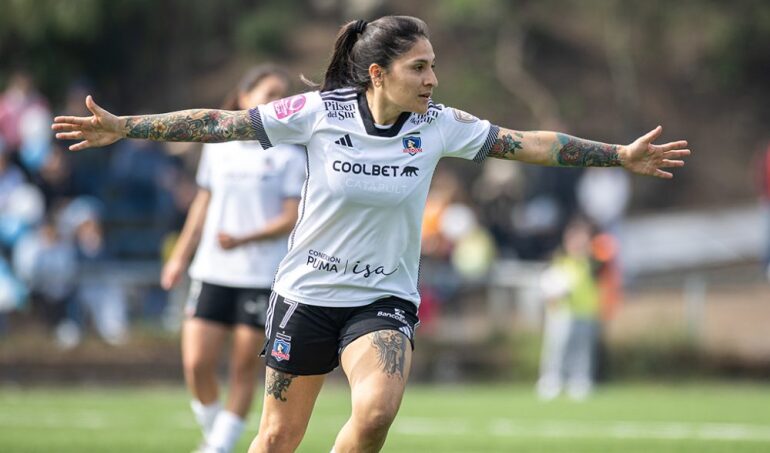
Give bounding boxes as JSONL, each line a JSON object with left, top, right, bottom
{"left": 262, "top": 293, "right": 419, "bottom": 376}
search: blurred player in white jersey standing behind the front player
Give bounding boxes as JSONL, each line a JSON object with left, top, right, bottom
{"left": 161, "top": 65, "right": 305, "bottom": 453}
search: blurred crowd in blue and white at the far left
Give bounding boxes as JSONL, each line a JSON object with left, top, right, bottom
{"left": 0, "top": 72, "right": 195, "bottom": 347}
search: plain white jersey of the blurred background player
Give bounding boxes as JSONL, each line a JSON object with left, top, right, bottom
{"left": 190, "top": 142, "right": 306, "bottom": 288}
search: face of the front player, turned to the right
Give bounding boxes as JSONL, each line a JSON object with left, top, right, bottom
{"left": 382, "top": 38, "right": 438, "bottom": 113}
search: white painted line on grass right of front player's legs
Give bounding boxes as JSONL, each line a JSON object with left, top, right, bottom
{"left": 392, "top": 417, "right": 770, "bottom": 441}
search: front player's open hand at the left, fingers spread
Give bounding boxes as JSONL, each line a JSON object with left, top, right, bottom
{"left": 51, "top": 95, "right": 123, "bottom": 151}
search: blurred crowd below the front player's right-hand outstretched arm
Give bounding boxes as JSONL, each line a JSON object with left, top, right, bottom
{"left": 420, "top": 160, "right": 631, "bottom": 321}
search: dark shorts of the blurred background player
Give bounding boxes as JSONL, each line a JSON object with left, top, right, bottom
{"left": 185, "top": 281, "right": 270, "bottom": 330}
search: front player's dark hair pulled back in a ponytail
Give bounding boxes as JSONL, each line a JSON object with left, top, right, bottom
{"left": 321, "top": 16, "right": 428, "bottom": 91}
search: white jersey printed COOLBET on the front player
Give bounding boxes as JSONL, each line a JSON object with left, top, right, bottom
{"left": 251, "top": 89, "right": 498, "bottom": 307}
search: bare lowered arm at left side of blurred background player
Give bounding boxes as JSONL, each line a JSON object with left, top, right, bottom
{"left": 160, "top": 189, "right": 211, "bottom": 290}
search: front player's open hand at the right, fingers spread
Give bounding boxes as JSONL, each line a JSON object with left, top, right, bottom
{"left": 621, "top": 126, "right": 690, "bottom": 179}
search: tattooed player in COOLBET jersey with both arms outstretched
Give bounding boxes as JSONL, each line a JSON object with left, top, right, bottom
{"left": 53, "top": 16, "right": 690, "bottom": 453}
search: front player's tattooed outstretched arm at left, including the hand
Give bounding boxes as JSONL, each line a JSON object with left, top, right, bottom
{"left": 51, "top": 96, "right": 256, "bottom": 151}
